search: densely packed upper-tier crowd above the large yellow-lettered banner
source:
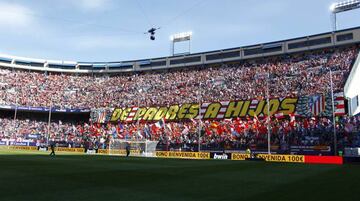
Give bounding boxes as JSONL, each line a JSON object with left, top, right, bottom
{"left": 0, "top": 46, "right": 358, "bottom": 109}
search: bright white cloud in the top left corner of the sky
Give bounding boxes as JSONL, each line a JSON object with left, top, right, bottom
{"left": 0, "top": 2, "right": 34, "bottom": 28}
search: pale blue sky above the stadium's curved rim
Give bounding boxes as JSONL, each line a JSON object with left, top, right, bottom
{"left": 0, "top": 0, "right": 360, "bottom": 61}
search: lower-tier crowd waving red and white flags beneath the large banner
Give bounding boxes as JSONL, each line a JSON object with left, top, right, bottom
{"left": 0, "top": 116, "right": 360, "bottom": 151}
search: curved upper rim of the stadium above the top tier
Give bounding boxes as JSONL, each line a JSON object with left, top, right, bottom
{"left": 0, "top": 27, "right": 360, "bottom": 74}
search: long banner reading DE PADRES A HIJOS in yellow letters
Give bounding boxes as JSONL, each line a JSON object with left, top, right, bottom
{"left": 91, "top": 93, "right": 345, "bottom": 123}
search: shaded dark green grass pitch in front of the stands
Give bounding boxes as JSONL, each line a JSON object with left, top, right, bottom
{"left": 0, "top": 150, "right": 360, "bottom": 201}
